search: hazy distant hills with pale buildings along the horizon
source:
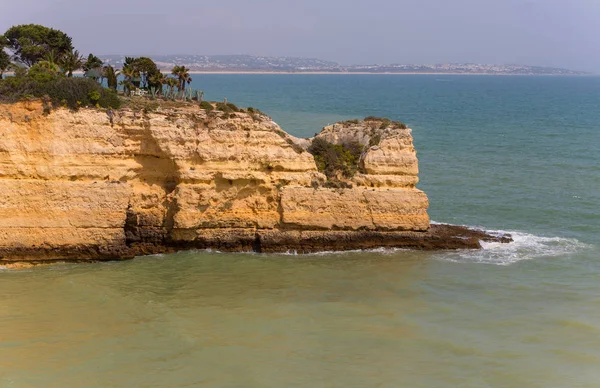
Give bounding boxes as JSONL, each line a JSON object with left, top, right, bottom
{"left": 100, "top": 55, "right": 589, "bottom": 75}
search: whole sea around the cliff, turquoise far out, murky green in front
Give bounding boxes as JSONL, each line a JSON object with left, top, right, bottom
{"left": 0, "top": 75, "right": 600, "bottom": 387}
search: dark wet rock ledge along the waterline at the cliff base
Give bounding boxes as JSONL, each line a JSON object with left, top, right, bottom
{"left": 0, "top": 224, "right": 513, "bottom": 268}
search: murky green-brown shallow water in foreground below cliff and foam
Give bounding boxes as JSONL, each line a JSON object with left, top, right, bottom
{"left": 0, "top": 251, "right": 600, "bottom": 387}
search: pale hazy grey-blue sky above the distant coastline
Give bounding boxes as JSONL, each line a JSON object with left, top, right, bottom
{"left": 0, "top": 0, "right": 600, "bottom": 72}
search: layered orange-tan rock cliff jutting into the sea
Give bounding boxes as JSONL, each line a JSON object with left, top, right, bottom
{"left": 0, "top": 102, "right": 508, "bottom": 263}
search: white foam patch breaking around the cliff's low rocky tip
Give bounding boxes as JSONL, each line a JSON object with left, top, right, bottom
{"left": 442, "top": 230, "right": 591, "bottom": 265}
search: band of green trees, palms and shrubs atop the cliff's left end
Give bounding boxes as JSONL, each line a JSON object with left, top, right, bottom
{"left": 0, "top": 24, "right": 209, "bottom": 111}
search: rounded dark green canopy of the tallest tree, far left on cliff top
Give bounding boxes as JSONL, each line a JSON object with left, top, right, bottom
{"left": 3, "top": 24, "right": 73, "bottom": 66}
